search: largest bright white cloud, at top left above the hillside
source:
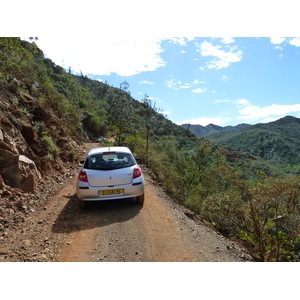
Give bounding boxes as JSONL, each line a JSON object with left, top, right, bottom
{"left": 37, "top": 35, "right": 166, "bottom": 76}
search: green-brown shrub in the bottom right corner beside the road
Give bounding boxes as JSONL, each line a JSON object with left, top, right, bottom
{"left": 202, "top": 176, "right": 300, "bottom": 261}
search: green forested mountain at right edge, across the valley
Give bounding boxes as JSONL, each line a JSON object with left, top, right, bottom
{"left": 207, "top": 116, "right": 300, "bottom": 164}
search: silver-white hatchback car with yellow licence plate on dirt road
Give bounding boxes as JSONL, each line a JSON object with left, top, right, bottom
{"left": 76, "top": 147, "right": 145, "bottom": 206}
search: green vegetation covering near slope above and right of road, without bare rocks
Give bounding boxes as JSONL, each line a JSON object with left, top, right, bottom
{"left": 0, "top": 38, "right": 300, "bottom": 261}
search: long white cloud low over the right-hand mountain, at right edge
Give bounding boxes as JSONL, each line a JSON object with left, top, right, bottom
{"left": 238, "top": 103, "right": 300, "bottom": 121}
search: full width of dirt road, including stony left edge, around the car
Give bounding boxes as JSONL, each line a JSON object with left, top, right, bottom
{"left": 0, "top": 145, "right": 251, "bottom": 262}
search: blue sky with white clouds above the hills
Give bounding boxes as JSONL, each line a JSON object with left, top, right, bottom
{"left": 37, "top": 37, "right": 300, "bottom": 126}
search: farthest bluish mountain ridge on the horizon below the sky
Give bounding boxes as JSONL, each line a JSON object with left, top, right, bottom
{"left": 181, "top": 124, "right": 251, "bottom": 137}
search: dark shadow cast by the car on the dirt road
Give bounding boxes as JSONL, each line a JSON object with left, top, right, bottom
{"left": 52, "top": 195, "right": 142, "bottom": 233}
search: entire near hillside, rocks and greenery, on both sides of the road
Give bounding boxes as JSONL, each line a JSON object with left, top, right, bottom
{"left": 0, "top": 38, "right": 300, "bottom": 261}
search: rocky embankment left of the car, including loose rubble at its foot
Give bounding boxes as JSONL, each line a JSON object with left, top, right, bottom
{"left": 0, "top": 80, "right": 81, "bottom": 245}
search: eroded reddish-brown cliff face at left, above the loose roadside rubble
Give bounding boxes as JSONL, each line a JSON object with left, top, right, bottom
{"left": 0, "top": 82, "right": 79, "bottom": 196}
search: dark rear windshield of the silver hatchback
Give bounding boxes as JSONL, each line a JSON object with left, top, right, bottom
{"left": 84, "top": 153, "right": 136, "bottom": 170}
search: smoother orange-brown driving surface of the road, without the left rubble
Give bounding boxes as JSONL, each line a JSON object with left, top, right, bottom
{"left": 53, "top": 175, "right": 251, "bottom": 262}
